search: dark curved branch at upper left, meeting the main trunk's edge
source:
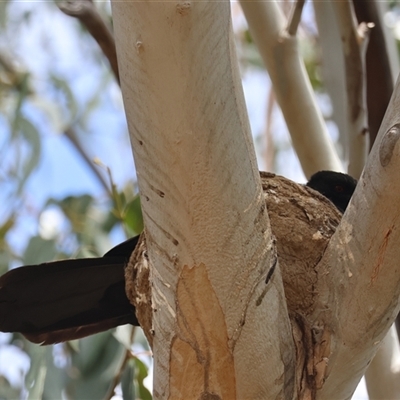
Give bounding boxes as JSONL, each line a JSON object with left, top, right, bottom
{"left": 58, "top": 0, "right": 119, "bottom": 84}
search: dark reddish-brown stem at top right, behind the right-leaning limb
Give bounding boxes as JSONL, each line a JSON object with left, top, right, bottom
{"left": 353, "top": 0, "right": 399, "bottom": 147}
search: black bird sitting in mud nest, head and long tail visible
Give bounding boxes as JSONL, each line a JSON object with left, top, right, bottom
{"left": 0, "top": 171, "right": 357, "bottom": 344}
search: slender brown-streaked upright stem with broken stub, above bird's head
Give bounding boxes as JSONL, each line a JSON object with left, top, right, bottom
{"left": 332, "top": 0, "right": 373, "bottom": 178}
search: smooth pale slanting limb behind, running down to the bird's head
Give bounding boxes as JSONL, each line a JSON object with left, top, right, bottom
{"left": 241, "top": 0, "right": 343, "bottom": 178}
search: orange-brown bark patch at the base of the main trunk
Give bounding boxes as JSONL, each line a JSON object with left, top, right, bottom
{"left": 170, "top": 264, "right": 236, "bottom": 399}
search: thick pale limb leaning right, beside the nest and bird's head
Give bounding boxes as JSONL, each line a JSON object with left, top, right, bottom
{"left": 309, "top": 74, "right": 400, "bottom": 399}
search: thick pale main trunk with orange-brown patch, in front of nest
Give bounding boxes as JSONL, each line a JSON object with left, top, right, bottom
{"left": 112, "top": 1, "right": 294, "bottom": 399}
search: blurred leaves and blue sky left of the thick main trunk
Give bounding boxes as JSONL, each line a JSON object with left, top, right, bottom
{"left": 0, "top": 2, "right": 151, "bottom": 400}
